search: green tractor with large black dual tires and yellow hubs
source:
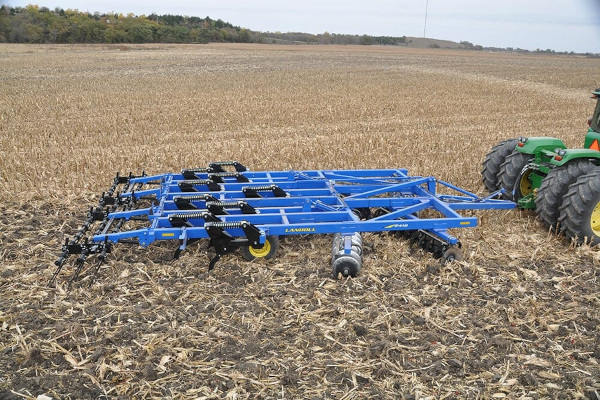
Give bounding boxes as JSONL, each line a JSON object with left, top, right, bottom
{"left": 481, "top": 88, "right": 600, "bottom": 245}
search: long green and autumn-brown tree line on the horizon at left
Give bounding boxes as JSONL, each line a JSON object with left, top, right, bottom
{"left": 0, "top": 5, "right": 406, "bottom": 45}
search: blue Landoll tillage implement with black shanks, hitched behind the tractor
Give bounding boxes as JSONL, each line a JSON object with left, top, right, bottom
{"left": 51, "top": 161, "right": 515, "bottom": 285}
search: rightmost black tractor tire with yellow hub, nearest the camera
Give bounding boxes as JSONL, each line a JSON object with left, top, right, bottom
{"left": 558, "top": 168, "right": 600, "bottom": 245}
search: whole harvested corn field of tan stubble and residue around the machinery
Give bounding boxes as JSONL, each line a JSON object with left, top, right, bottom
{"left": 0, "top": 45, "right": 600, "bottom": 399}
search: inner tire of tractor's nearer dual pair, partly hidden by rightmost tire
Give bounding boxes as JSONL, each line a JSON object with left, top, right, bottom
{"left": 535, "top": 160, "right": 596, "bottom": 228}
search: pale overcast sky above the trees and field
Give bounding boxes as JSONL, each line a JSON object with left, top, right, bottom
{"left": 0, "top": 0, "right": 600, "bottom": 53}
